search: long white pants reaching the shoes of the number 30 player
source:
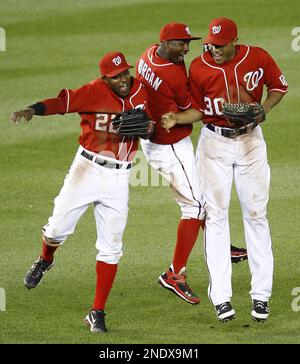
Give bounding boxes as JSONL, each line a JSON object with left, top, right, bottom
{"left": 196, "top": 126, "right": 273, "bottom": 305}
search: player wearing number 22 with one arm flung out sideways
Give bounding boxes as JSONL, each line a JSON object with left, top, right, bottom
{"left": 11, "top": 52, "right": 152, "bottom": 333}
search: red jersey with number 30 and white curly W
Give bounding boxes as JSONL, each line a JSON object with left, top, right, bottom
{"left": 189, "top": 45, "right": 287, "bottom": 127}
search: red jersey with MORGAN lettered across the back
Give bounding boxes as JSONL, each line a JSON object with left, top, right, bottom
{"left": 136, "top": 45, "right": 192, "bottom": 144}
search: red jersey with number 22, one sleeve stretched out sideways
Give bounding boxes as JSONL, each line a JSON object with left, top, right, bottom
{"left": 42, "top": 78, "right": 149, "bottom": 161}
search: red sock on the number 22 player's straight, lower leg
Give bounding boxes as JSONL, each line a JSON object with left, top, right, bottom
{"left": 93, "top": 261, "right": 118, "bottom": 310}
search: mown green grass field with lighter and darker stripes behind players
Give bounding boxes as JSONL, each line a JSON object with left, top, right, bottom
{"left": 0, "top": 0, "right": 300, "bottom": 344}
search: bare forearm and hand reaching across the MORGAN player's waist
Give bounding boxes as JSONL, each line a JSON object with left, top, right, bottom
{"left": 160, "top": 108, "right": 203, "bottom": 131}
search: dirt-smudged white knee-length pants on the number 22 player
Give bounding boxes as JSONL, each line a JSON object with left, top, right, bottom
{"left": 43, "top": 146, "right": 130, "bottom": 264}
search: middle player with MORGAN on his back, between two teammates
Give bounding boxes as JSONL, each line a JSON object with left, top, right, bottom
{"left": 136, "top": 22, "right": 247, "bottom": 304}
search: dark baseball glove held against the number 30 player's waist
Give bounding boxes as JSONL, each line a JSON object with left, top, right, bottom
{"left": 222, "top": 103, "right": 266, "bottom": 127}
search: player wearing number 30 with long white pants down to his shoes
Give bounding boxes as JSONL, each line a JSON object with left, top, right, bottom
{"left": 162, "top": 18, "right": 287, "bottom": 321}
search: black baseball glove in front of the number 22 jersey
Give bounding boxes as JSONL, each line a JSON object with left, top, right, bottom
{"left": 112, "top": 109, "right": 154, "bottom": 139}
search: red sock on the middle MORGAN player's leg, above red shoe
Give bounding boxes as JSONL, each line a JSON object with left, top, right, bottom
{"left": 173, "top": 219, "right": 205, "bottom": 274}
